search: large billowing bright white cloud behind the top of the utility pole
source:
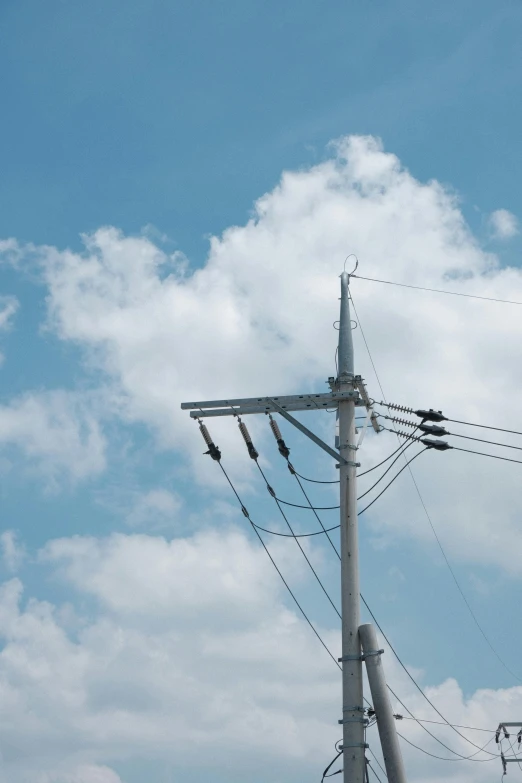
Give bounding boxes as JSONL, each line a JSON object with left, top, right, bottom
{"left": 0, "top": 137, "right": 522, "bottom": 574}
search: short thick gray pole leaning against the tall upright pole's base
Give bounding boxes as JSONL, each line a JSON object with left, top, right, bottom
{"left": 359, "top": 625, "right": 406, "bottom": 783}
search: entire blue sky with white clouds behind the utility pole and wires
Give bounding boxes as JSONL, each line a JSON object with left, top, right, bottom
{"left": 0, "top": 0, "right": 522, "bottom": 783}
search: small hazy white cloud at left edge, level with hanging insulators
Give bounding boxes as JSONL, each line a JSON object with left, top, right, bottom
{"left": 0, "top": 390, "right": 105, "bottom": 483}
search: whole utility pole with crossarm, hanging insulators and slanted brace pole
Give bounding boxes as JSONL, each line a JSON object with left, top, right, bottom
{"left": 181, "top": 272, "right": 406, "bottom": 783}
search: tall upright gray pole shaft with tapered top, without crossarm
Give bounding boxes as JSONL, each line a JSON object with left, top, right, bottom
{"left": 337, "top": 272, "right": 365, "bottom": 783}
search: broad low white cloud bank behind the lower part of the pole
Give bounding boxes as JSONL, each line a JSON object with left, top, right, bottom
{"left": 0, "top": 530, "right": 522, "bottom": 783}
